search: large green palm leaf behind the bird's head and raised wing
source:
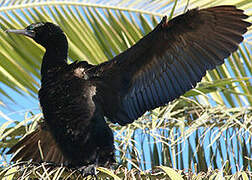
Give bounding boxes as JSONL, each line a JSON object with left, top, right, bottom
{"left": 0, "top": 1, "right": 252, "bottom": 106}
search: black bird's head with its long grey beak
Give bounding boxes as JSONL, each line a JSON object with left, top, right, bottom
{"left": 6, "top": 22, "right": 65, "bottom": 48}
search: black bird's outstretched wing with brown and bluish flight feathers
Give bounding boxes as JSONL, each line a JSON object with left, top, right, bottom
{"left": 97, "top": 6, "right": 250, "bottom": 125}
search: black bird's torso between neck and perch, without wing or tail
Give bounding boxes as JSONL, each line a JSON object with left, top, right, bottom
{"left": 39, "top": 63, "right": 113, "bottom": 166}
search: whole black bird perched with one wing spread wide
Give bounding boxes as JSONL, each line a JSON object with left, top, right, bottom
{"left": 7, "top": 6, "right": 251, "bottom": 171}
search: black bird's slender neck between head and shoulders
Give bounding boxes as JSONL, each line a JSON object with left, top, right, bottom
{"left": 41, "top": 34, "right": 68, "bottom": 79}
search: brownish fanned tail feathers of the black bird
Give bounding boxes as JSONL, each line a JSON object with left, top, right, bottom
{"left": 7, "top": 123, "right": 68, "bottom": 165}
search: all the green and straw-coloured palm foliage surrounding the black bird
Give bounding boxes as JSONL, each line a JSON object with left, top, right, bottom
{"left": 0, "top": 0, "right": 252, "bottom": 179}
